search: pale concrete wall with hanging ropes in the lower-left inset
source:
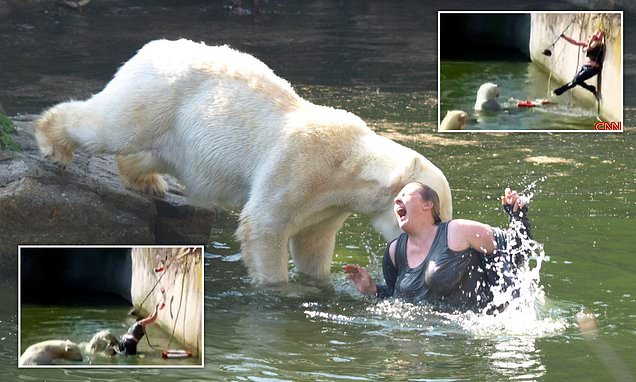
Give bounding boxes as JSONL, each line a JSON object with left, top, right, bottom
{"left": 130, "top": 247, "right": 203, "bottom": 355}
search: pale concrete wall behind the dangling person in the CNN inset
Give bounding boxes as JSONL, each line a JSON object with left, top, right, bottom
{"left": 530, "top": 13, "right": 623, "bottom": 122}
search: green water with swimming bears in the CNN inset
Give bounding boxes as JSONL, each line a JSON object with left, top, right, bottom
{"left": 439, "top": 60, "right": 597, "bottom": 130}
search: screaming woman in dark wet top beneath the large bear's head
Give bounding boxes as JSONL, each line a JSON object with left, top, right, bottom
{"left": 343, "top": 183, "right": 530, "bottom": 313}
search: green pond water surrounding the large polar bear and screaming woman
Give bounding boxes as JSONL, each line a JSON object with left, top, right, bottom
{"left": 0, "top": 1, "right": 636, "bottom": 381}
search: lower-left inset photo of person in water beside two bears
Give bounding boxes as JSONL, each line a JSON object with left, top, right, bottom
{"left": 18, "top": 246, "right": 203, "bottom": 368}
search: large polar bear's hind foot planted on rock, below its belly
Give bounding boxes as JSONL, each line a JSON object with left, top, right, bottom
{"left": 115, "top": 151, "right": 168, "bottom": 196}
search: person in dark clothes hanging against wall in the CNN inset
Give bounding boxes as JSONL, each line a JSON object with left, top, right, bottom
{"left": 553, "top": 31, "right": 605, "bottom": 97}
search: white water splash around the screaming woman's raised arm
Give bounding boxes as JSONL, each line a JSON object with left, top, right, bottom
{"left": 342, "top": 176, "right": 572, "bottom": 338}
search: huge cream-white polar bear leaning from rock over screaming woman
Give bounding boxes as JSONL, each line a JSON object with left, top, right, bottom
{"left": 36, "top": 40, "right": 452, "bottom": 284}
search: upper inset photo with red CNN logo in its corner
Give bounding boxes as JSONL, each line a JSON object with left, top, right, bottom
{"left": 438, "top": 11, "right": 623, "bottom": 132}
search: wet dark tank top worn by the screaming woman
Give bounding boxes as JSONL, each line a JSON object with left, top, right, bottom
{"left": 393, "top": 222, "right": 492, "bottom": 310}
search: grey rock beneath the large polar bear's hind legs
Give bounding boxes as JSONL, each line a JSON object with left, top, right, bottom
{"left": 0, "top": 116, "right": 228, "bottom": 273}
